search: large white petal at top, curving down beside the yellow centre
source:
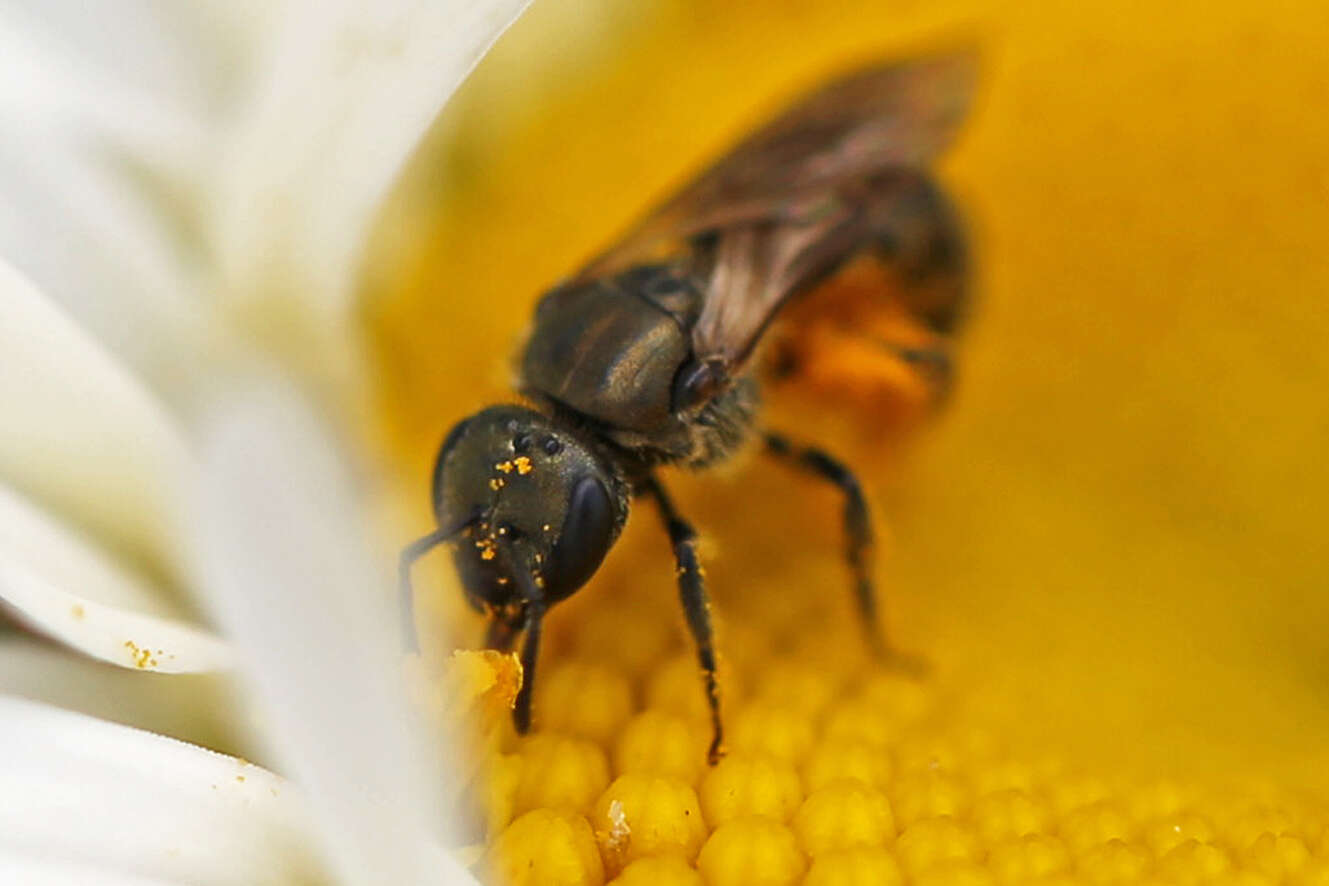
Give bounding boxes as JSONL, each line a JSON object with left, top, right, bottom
{"left": 215, "top": 0, "right": 529, "bottom": 321}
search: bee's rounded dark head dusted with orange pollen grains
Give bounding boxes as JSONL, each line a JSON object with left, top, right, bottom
{"left": 433, "top": 406, "right": 627, "bottom": 612}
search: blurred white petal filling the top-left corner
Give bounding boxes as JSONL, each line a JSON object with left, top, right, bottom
{"left": 0, "top": 6, "right": 220, "bottom": 381}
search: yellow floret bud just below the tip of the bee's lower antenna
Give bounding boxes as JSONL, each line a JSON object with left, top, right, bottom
{"left": 514, "top": 733, "right": 609, "bottom": 813}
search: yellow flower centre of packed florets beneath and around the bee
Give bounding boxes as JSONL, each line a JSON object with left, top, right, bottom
{"left": 371, "top": 1, "right": 1329, "bottom": 885}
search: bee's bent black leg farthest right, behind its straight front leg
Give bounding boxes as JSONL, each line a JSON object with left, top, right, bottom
{"left": 763, "top": 432, "right": 924, "bottom": 672}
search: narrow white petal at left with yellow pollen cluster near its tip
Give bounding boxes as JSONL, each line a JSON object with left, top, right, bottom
{"left": 0, "top": 486, "right": 231, "bottom": 673}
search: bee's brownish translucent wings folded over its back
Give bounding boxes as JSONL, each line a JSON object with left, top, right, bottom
{"left": 577, "top": 52, "right": 977, "bottom": 365}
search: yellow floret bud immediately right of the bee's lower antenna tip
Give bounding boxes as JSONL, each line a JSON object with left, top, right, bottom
{"left": 536, "top": 662, "right": 633, "bottom": 745}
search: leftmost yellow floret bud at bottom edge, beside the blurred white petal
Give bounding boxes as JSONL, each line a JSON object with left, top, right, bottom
{"left": 482, "top": 809, "right": 605, "bottom": 886}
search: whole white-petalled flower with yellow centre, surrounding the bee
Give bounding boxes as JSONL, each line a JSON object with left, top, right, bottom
{"left": 0, "top": 0, "right": 1329, "bottom": 886}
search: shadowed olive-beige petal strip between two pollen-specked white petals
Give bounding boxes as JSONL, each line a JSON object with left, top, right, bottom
{"left": 0, "top": 632, "right": 241, "bottom": 754}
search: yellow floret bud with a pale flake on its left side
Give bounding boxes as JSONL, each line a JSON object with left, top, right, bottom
{"left": 591, "top": 773, "right": 706, "bottom": 873}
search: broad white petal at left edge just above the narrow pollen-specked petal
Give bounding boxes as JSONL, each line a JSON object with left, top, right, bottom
{"left": 0, "top": 259, "right": 189, "bottom": 579}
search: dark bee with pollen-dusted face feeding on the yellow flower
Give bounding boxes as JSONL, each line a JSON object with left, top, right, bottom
{"left": 400, "top": 53, "right": 975, "bottom": 762}
